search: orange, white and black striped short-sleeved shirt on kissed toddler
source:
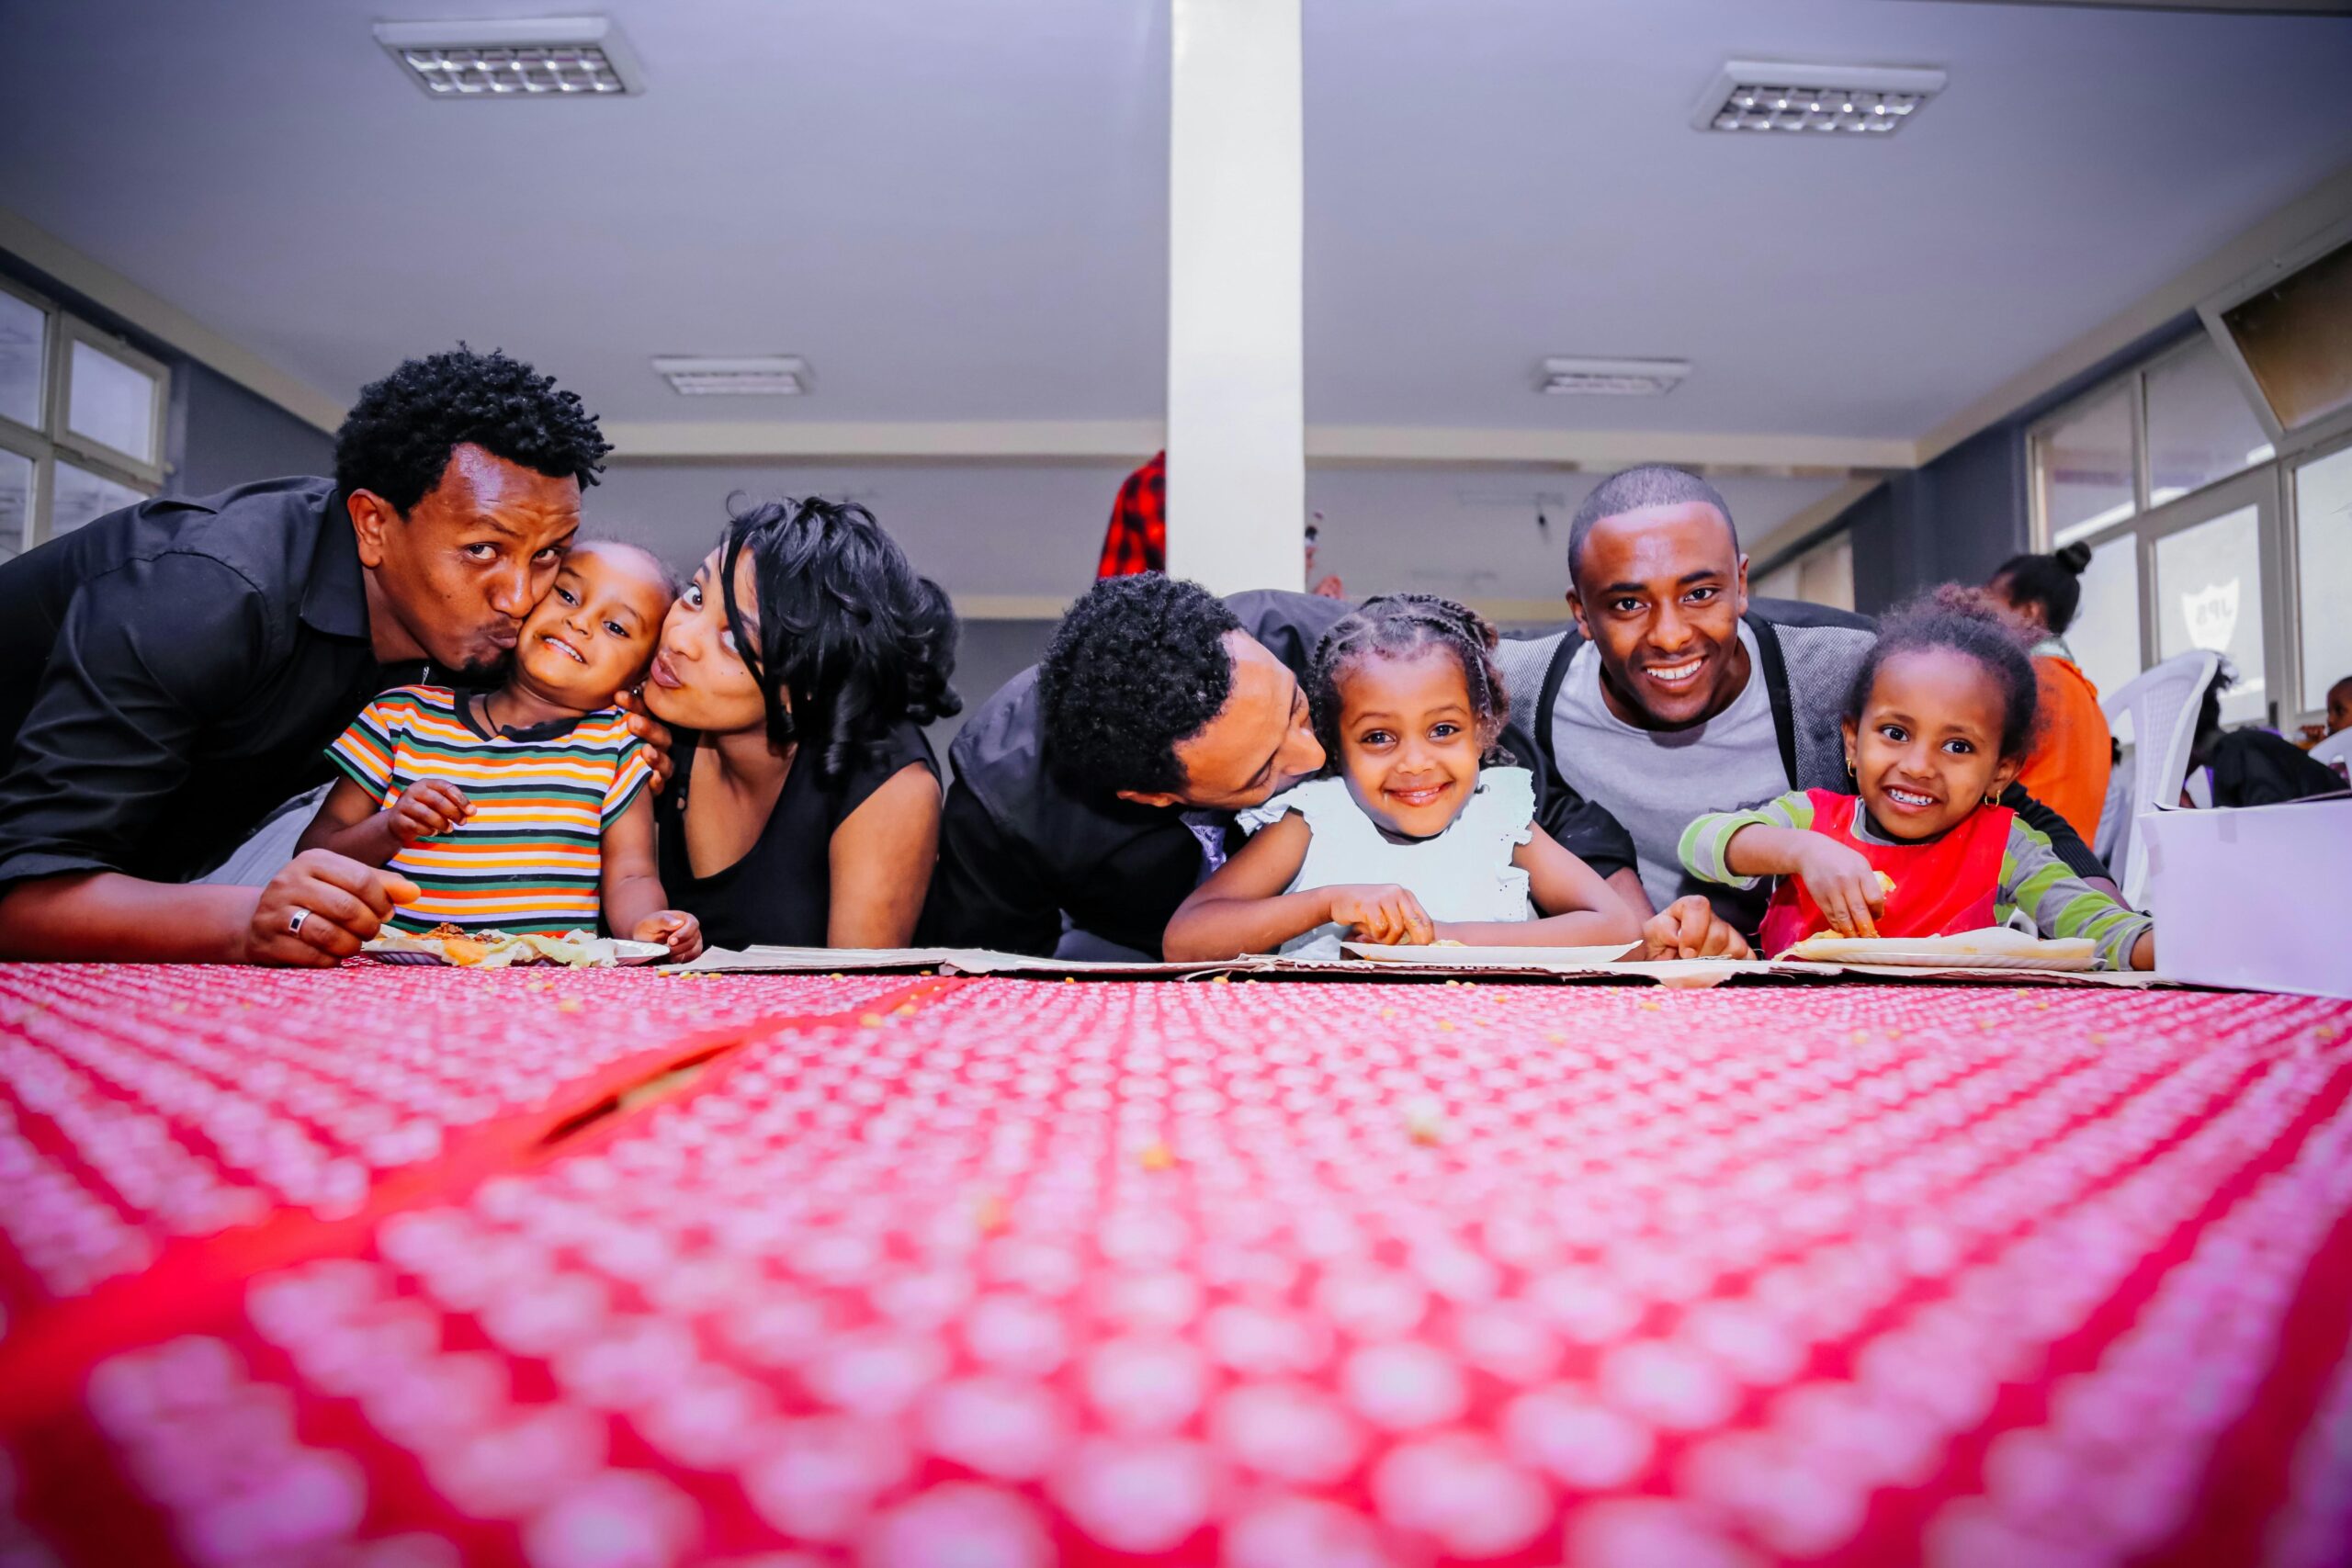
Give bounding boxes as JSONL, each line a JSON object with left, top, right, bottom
{"left": 327, "top": 686, "right": 651, "bottom": 933}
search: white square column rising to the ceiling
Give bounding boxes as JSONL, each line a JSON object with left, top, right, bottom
{"left": 1167, "top": 0, "right": 1307, "bottom": 592}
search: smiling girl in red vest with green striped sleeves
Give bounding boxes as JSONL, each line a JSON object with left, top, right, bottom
{"left": 1681, "top": 588, "right": 2157, "bottom": 968}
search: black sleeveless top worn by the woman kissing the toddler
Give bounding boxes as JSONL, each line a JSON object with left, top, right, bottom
{"left": 654, "top": 722, "right": 938, "bottom": 947}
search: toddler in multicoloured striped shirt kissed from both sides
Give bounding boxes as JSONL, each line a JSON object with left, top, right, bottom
{"left": 301, "top": 543, "right": 703, "bottom": 962}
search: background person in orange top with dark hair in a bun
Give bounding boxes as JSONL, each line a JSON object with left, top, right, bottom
{"left": 1987, "top": 541, "right": 2114, "bottom": 844}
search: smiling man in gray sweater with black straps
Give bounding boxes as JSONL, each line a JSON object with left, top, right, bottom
{"left": 1498, "top": 466, "right": 2112, "bottom": 933}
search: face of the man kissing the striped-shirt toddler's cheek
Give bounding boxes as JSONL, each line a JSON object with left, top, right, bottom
{"left": 348, "top": 445, "right": 581, "bottom": 674}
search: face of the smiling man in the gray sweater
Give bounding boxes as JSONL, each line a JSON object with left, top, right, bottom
{"left": 1569, "top": 501, "right": 1747, "bottom": 728}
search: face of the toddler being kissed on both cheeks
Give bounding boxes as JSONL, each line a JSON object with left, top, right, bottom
{"left": 515, "top": 543, "right": 671, "bottom": 712}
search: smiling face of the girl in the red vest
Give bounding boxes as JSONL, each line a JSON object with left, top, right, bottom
{"left": 1847, "top": 649, "right": 2025, "bottom": 840}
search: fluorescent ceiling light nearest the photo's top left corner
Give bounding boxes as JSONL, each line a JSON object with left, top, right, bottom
{"left": 377, "top": 17, "right": 644, "bottom": 98}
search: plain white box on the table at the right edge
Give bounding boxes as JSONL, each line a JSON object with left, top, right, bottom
{"left": 2138, "top": 797, "right": 2352, "bottom": 997}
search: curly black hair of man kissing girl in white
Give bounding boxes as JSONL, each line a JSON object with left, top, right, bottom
{"left": 1037, "top": 571, "right": 1242, "bottom": 795}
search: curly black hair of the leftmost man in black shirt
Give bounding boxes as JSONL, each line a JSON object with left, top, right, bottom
{"left": 334, "top": 344, "right": 612, "bottom": 517}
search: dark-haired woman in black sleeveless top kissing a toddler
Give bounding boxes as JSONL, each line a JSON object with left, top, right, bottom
{"left": 644, "top": 499, "right": 962, "bottom": 947}
